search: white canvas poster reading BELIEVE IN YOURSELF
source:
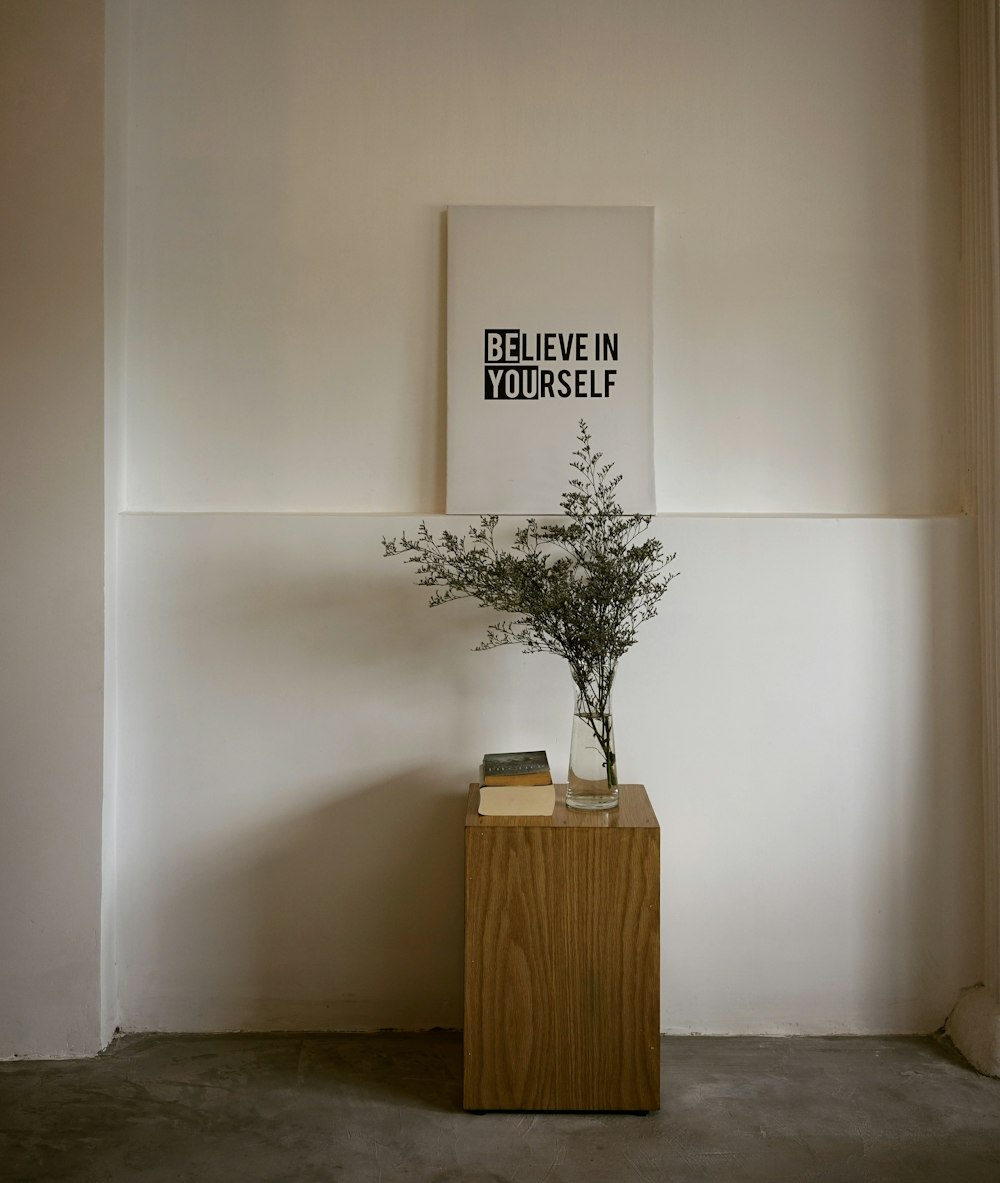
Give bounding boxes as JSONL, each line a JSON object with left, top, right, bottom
{"left": 447, "top": 206, "right": 656, "bottom": 515}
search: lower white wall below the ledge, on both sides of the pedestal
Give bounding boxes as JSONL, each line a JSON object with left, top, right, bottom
{"left": 120, "top": 515, "right": 981, "bottom": 1033}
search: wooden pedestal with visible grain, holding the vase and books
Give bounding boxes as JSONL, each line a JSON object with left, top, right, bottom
{"left": 464, "top": 784, "right": 659, "bottom": 1112}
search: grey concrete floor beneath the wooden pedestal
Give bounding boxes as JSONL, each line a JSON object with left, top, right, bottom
{"left": 0, "top": 1033, "right": 1000, "bottom": 1183}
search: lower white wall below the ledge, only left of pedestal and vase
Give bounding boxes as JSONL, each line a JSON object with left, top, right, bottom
{"left": 120, "top": 515, "right": 568, "bottom": 1030}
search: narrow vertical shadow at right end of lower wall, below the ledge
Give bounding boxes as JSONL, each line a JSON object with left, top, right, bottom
{"left": 866, "top": 521, "right": 983, "bottom": 1033}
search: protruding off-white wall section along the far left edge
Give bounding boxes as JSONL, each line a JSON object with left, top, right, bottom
{"left": 0, "top": 0, "right": 104, "bottom": 1058}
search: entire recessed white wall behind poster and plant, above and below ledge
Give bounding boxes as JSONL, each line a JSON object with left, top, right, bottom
{"left": 112, "top": 0, "right": 981, "bottom": 1032}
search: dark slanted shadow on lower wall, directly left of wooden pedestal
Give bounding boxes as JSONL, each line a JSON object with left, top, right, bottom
{"left": 163, "top": 769, "right": 465, "bottom": 1030}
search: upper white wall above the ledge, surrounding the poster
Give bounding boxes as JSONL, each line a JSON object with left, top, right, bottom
{"left": 128, "top": 0, "right": 959, "bottom": 513}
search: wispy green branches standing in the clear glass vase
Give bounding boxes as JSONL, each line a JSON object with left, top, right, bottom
{"left": 382, "top": 419, "right": 677, "bottom": 784}
